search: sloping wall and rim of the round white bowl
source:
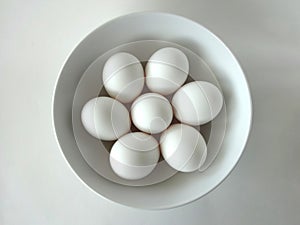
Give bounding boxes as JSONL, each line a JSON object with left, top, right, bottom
{"left": 53, "top": 12, "right": 252, "bottom": 209}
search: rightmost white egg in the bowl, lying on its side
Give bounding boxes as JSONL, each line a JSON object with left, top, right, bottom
{"left": 172, "top": 81, "right": 223, "bottom": 126}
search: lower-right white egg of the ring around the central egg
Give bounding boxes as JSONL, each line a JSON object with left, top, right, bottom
{"left": 160, "top": 124, "right": 207, "bottom": 172}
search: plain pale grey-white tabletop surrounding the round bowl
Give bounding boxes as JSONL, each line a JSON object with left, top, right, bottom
{"left": 0, "top": 0, "right": 300, "bottom": 225}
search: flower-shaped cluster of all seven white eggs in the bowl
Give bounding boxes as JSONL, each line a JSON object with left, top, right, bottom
{"left": 81, "top": 47, "right": 223, "bottom": 180}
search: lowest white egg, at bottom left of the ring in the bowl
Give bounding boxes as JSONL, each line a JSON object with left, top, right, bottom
{"left": 110, "top": 132, "right": 160, "bottom": 180}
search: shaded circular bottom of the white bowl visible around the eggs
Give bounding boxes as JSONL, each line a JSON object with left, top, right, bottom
{"left": 72, "top": 40, "right": 226, "bottom": 186}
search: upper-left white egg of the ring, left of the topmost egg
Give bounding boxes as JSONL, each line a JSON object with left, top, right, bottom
{"left": 103, "top": 52, "right": 144, "bottom": 103}
